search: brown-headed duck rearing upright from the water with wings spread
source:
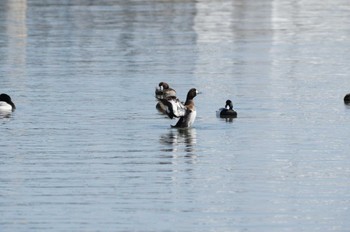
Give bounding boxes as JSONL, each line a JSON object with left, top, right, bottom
{"left": 161, "top": 88, "right": 198, "bottom": 128}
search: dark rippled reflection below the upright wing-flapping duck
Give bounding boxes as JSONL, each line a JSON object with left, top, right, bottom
{"left": 160, "top": 128, "right": 196, "bottom": 157}
